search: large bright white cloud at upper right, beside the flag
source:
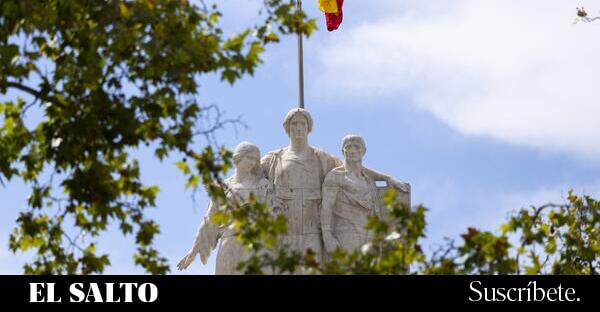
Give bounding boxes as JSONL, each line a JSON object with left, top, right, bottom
{"left": 315, "top": 0, "right": 600, "bottom": 159}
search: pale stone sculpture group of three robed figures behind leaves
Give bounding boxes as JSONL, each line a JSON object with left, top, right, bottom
{"left": 178, "top": 108, "right": 410, "bottom": 275}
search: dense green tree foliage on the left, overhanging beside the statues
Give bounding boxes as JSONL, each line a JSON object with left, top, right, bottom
{"left": 0, "top": 0, "right": 315, "bottom": 274}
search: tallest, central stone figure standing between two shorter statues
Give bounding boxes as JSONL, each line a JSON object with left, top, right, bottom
{"left": 261, "top": 108, "right": 405, "bottom": 261}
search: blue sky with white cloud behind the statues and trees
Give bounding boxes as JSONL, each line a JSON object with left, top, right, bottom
{"left": 0, "top": 0, "right": 600, "bottom": 274}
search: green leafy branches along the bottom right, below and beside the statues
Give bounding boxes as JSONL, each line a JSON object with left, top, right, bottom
{"left": 215, "top": 191, "right": 600, "bottom": 275}
